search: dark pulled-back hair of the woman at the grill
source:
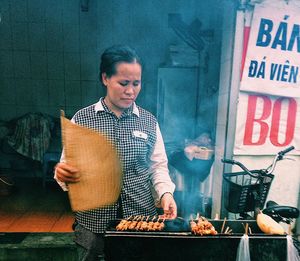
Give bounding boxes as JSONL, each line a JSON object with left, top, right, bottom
{"left": 100, "top": 45, "right": 142, "bottom": 81}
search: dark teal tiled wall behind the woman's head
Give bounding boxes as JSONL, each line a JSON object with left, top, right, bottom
{"left": 0, "top": 0, "right": 222, "bottom": 120}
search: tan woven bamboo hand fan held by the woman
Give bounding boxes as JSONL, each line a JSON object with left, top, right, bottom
{"left": 61, "top": 112, "right": 122, "bottom": 211}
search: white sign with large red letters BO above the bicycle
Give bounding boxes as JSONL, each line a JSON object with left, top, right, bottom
{"left": 234, "top": 92, "right": 300, "bottom": 155}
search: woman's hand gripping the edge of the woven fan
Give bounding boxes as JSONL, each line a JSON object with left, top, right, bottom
{"left": 55, "top": 162, "right": 80, "bottom": 183}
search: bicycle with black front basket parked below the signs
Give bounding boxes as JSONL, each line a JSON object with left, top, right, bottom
{"left": 222, "top": 146, "right": 300, "bottom": 253}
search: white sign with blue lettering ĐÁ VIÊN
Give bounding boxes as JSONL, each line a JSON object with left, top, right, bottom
{"left": 240, "top": 5, "right": 300, "bottom": 98}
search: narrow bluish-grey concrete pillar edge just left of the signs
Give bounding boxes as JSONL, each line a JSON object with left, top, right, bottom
{"left": 212, "top": 2, "right": 238, "bottom": 215}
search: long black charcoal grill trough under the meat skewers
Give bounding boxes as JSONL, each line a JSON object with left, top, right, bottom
{"left": 105, "top": 220, "right": 287, "bottom": 261}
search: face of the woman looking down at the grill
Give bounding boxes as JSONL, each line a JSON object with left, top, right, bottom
{"left": 102, "top": 62, "right": 142, "bottom": 116}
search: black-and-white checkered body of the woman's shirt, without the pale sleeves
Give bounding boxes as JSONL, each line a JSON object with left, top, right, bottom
{"left": 72, "top": 98, "right": 168, "bottom": 233}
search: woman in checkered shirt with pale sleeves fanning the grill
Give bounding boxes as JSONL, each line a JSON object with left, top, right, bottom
{"left": 55, "top": 46, "right": 177, "bottom": 260}
